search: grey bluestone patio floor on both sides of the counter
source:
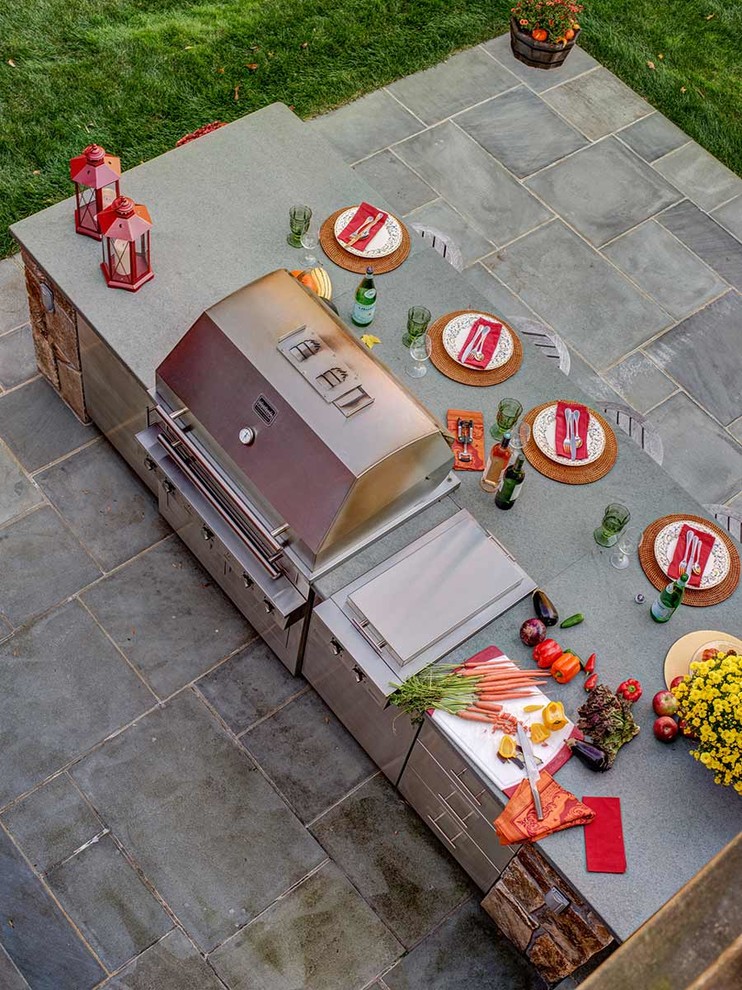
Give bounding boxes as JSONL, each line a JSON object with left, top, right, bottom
{"left": 0, "top": 31, "right": 742, "bottom": 990}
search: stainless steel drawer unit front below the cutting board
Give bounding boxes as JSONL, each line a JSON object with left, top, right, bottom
{"left": 408, "top": 732, "right": 517, "bottom": 871}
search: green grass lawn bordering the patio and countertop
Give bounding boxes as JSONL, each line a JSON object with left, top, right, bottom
{"left": 0, "top": 0, "right": 742, "bottom": 255}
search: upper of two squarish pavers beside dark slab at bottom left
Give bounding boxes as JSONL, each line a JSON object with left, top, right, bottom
{"left": 2, "top": 773, "right": 105, "bottom": 873}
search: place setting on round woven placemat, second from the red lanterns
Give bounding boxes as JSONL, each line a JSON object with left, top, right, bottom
{"left": 428, "top": 310, "right": 523, "bottom": 386}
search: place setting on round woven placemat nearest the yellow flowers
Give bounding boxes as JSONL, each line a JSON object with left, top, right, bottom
{"left": 639, "top": 515, "right": 740, "bottom": 606}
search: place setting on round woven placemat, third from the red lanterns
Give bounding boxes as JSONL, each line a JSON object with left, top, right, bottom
{"left": 523, "top": 399, "right": 618, "bottom": 485}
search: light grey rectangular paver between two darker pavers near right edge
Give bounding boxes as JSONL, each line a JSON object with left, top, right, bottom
{"left": 603, "top": 220, "right": 728, "bottom": 320}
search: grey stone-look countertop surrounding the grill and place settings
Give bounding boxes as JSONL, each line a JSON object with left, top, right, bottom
{"left": 12, "top": 104, "right": 742, "bottom": 939}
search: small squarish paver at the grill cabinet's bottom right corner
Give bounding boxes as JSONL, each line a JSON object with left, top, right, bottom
{"left": 198, "top": 639, "right": 307, "bottom": 733}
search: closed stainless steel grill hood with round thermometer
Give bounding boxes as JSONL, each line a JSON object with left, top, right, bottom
{"left": 156, "top": 270, "right": 453, "bottom": 569}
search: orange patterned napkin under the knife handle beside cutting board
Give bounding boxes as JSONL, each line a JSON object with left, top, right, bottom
{"left": 494, "top": 770, "right": 595, "bottom": 846}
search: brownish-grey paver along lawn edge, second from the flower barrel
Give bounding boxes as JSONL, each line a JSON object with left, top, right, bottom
{"left": 544, "top": 67, "right": 652, "bottom": 141}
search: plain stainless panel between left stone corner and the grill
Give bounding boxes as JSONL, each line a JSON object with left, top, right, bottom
{"left": 77, "top": 313, "right": 157, "bottom": 492}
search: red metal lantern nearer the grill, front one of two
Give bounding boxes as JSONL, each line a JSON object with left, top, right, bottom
{"left": 98, "top": 196, "right": 155, "bottom": 292}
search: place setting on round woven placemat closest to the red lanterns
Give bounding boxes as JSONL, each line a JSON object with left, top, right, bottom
{"left": 319, "top": 203, "right": 411, "bottom": 275}
